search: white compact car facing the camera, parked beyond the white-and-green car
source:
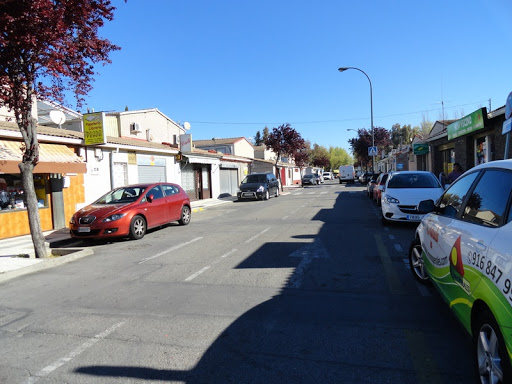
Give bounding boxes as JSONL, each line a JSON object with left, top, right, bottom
{"left": 381, "top": 171, "right": 444, "bottom": 224}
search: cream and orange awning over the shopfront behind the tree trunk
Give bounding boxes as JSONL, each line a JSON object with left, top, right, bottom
{"left": 0, "top": 140, "right": 87, "bottom": 173}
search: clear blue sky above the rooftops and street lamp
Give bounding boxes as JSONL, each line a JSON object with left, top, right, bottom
{"left": 83, "top": 0, "right": 512, "bottom": 150}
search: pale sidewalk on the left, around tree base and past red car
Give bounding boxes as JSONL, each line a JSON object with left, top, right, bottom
{"left": 0, "top": 196, "right": 262, "bottom": 283}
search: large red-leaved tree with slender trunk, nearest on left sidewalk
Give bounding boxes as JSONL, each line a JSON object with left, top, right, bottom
{"left": 0, "top": 0, "right": 119, "bottom": 257}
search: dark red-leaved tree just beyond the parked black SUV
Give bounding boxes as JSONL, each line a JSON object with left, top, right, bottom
{"left": 265, "top": 123, "right": 305, "bottom": 190}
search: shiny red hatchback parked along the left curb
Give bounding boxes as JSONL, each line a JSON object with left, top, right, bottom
{"left": 69, "top": 183, "right": 192, "bottom": 240}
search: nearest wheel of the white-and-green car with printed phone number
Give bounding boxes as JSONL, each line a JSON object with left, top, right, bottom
{"left": 473, "top": 310, "right": 512, "bottom": 383}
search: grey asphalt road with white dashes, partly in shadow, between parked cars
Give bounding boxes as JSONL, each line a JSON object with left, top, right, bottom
{"left": 0, "top": 181, "right": 475, "bottom": 384}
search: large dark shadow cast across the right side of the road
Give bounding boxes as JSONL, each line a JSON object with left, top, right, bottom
{"left": 75, "top": 193, "right": 472, "bottom": 383}
